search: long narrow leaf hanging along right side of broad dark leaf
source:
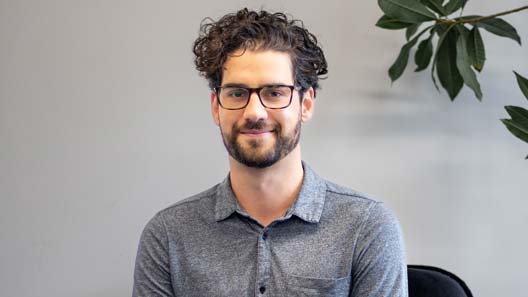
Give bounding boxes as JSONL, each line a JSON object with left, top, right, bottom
{"left": 456, "top": 25, "right": 482, "bottom": 100}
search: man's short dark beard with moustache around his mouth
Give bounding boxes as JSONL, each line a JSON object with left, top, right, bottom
{"left": 220, "top": 115, "right": 301, "bottom": 168}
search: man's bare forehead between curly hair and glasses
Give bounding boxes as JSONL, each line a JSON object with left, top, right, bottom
{"left": 222, "top": 50, "right": 294, "bottom": 87}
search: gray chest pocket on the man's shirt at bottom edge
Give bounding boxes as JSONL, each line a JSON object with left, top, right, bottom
{"left": 286, "top": 275, "right": 350, "bottom": 297}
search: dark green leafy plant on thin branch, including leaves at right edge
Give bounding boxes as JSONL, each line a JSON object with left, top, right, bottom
{"left": 376, "top": 0, "right": 528, "bottom": 159}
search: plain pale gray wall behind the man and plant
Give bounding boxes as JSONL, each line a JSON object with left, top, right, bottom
{"left": 0, "top": 0, "right": 528, "bottom": 297}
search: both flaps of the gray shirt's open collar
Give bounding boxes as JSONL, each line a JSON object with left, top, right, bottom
{"left": 215, "top": 161, "right": 326, "bottom": 223}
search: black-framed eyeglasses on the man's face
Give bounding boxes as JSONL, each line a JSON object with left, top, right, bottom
{"left": 214, "top": 85, "right": 295, "bottom": 110}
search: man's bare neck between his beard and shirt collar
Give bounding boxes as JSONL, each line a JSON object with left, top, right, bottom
{"left": 229, "top": 145, "right": 304, "bottom": 226}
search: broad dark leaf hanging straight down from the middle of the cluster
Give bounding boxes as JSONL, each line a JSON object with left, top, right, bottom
{"left": 436, "top": 30, "right": 464, "bottom": 100}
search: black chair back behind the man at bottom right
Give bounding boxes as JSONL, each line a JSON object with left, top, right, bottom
{"left": 407, "top": 265, "right": 473, "bottom": 297}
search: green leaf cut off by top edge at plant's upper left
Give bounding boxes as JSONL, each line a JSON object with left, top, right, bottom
{"left": 378, "top": 0, "right": 436, "bottom": 24}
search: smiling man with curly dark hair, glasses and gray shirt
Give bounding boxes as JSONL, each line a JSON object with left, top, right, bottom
{"left": 133, "top": 9, "right": 407, "bottom": 297}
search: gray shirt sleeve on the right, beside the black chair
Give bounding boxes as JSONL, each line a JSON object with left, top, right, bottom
{"left": 350, "top": 202, "right": 408, "bottom": 297}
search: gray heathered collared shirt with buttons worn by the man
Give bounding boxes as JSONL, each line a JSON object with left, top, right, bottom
{"left": 132, "top": 163, "right": 408, "bottom": 297}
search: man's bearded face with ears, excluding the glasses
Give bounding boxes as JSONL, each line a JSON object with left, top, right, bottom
{"left": 211, "top": 50, "right": 313, "bottom": 168}
